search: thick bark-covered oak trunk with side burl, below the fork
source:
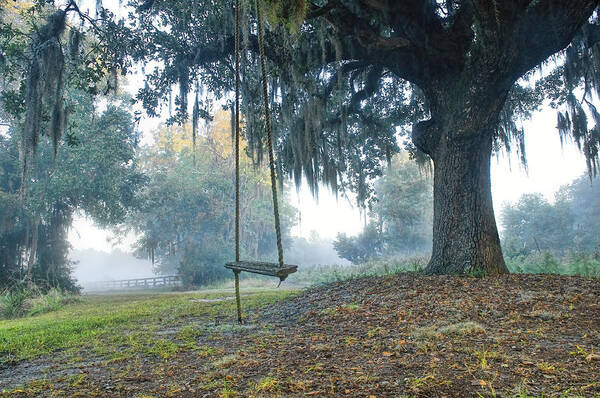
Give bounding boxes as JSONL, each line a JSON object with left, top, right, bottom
{"left": 412, "top": 74, "right": 511, "bottom": 275}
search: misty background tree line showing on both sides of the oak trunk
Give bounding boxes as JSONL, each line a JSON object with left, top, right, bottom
{"left": 334, "top": 156, "right": 600, "bottom": 275}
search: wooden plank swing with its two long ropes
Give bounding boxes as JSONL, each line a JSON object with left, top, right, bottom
{"left": 225, "top": 0, "right": 298, "bottom": 323}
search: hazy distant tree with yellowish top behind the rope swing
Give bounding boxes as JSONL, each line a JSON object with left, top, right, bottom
{"left": 128, "top": 111, "right": 295, "bottom": 285}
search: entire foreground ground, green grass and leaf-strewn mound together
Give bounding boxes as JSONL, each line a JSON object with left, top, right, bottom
{"left": 0, "top": 274, "right": 600, "bottom": 398}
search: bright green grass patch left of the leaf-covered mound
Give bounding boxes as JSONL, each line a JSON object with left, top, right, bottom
{"left": 0, "top": 289, "right": 292, "bottom": 363}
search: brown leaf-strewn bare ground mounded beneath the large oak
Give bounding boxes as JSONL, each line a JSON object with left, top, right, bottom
{"left": 0, "top": 274, "right": 600, "bottom": 397}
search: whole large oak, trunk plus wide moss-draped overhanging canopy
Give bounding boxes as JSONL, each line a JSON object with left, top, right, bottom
{"left": 3, "top": 0, "right": 600, "bottom": 273}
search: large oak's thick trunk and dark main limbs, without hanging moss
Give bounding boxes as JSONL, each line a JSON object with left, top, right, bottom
{"left": 298, "top": 0, "right": 598, "bottom": 274}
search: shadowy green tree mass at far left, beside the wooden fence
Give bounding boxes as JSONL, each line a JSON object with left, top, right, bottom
{"left": 0, "top": 94, "right": 144, "bottom": 289}
